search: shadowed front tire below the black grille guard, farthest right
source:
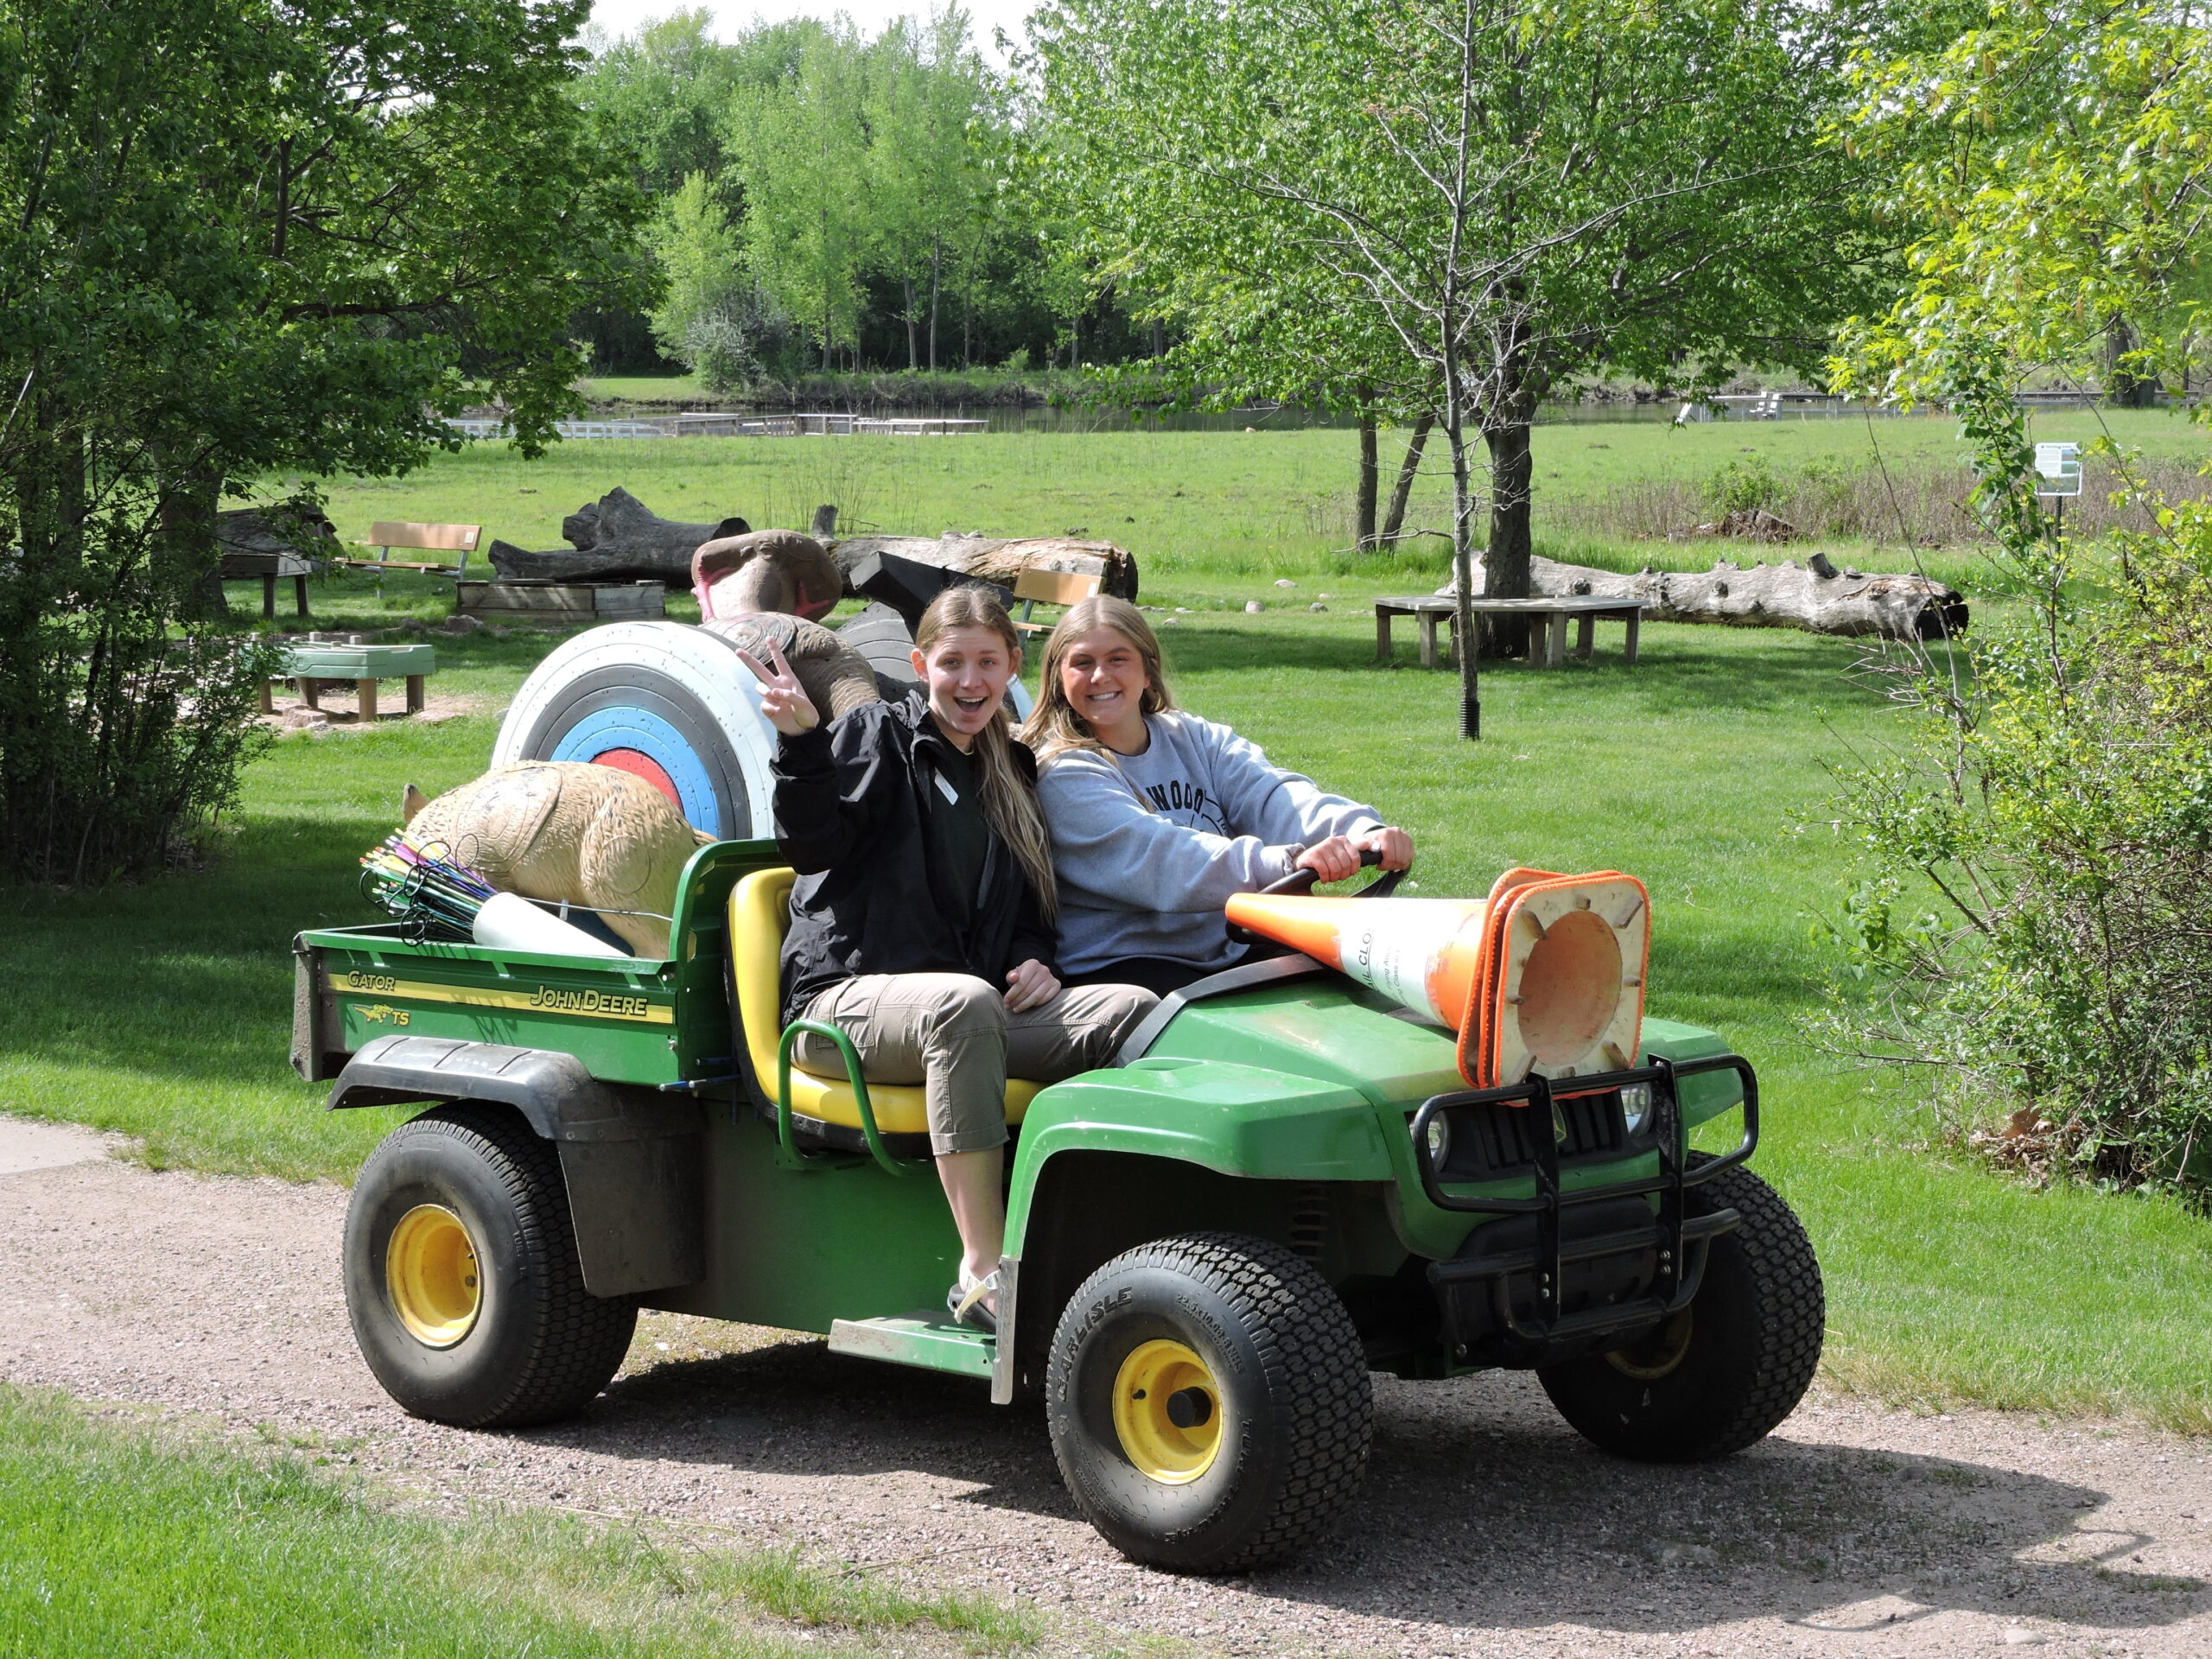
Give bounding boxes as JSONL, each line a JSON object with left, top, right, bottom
{"left": 1537, "top": 1170, "right": 1827, "bottom": 1462}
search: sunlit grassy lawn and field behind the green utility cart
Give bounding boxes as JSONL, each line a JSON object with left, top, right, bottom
{"left": 0, "top": 416, "right": 2212, "bottom": 1433}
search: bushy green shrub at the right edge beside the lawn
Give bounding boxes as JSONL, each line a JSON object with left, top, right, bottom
{"left": 1829, "top": 367, "right": 2212, "bottom": 1201}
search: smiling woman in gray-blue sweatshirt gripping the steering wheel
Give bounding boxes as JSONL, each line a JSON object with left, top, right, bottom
{"left": 1022, "top": 595, "right": 1414, "bottom": 995}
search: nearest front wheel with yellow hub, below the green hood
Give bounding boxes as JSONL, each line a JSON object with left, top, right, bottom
{"left": 1046, "top": 1232, "right": 1374, "bottom": 1573}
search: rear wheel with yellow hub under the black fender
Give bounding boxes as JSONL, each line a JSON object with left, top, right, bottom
{"left": 345, "top": 1103, "right": 637, "bottom": 1429}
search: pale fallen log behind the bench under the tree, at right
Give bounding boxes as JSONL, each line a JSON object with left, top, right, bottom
{"left": 1438, "top": 553, "right": 1967, "bottom": 639}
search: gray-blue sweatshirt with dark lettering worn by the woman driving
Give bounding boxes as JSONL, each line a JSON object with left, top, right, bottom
{"left": 1038, "top": 710, "right": 1382, "bottom": 973}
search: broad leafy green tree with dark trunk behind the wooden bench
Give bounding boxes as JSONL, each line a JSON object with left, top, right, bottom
{"left": 1033, "top": 0, "right": 1865, "bottom": 703}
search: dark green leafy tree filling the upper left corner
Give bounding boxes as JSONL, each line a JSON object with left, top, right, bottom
{"left": 0, "top": 0, "right": 644, "bottom": 880}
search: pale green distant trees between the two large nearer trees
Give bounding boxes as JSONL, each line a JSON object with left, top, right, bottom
{"left": 580, "top": 7, "right": 1141, "bottom": 378}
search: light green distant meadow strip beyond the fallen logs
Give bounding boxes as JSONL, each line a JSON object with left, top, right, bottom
{"left": 298, "top": 410, "right": 2205, "bottom": 604}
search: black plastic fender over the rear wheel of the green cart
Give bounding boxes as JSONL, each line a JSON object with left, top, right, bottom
{"left": 329, "top": 1035, "right": 706, "bottom": 1296}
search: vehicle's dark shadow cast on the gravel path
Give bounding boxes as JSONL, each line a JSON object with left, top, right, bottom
{"left": 529, "top": 1338, "right": 2212, "bottom": 1635}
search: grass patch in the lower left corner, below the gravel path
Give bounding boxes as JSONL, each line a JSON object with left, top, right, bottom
{"left": 0, "top": 1387, "right": 1039, "bottom": 1659}
